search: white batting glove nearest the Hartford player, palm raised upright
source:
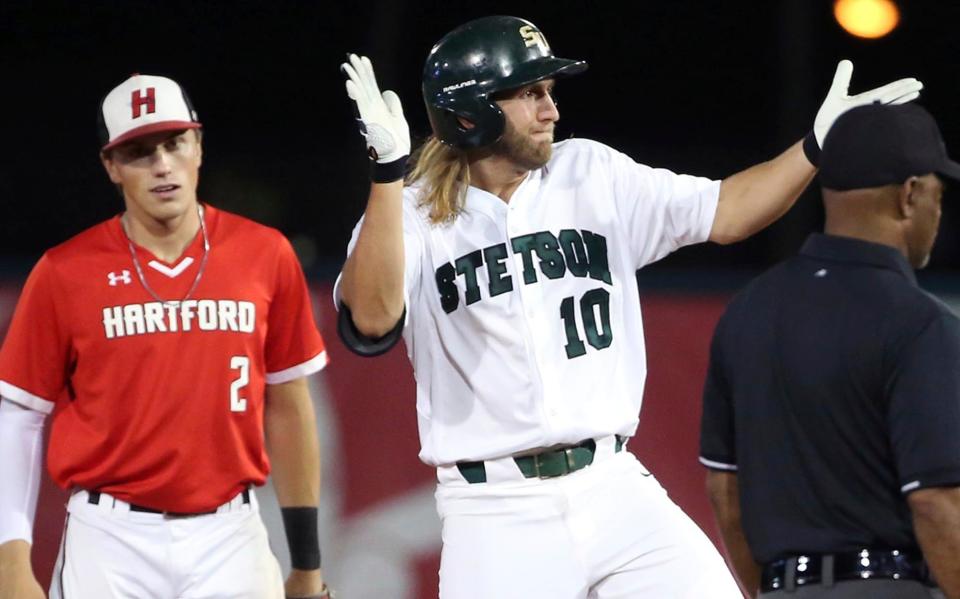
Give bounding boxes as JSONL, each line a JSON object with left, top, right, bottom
{"left": 340, "top": 54, "right": 410, "bottom": 164}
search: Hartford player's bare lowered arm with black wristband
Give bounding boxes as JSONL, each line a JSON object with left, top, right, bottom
{"left": 263, "top": 378, "right": 332, "bottom": 598}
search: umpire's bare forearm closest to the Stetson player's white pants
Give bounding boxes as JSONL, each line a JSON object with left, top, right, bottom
{"left": 707, "top": 470, "right": 760, "bottom": 597}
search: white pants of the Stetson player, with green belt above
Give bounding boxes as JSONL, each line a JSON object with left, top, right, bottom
{"left": 436, "top": 439, "right": 743, "bottom": 599}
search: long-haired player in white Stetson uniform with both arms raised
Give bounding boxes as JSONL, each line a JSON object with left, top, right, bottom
{"left": 335, "top": 17, "right": 922, "bottom": 599}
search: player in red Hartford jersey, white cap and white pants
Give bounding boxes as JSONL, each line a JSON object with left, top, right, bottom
{"left": 0, "top": 75, "right": 327, "bottom": 599}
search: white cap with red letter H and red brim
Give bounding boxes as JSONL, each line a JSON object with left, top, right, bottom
{"left": 100, "top": 73, "right": 200, "bottom": 151}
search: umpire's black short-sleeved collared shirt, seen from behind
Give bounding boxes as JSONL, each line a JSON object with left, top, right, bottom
{"left": 700, "top": 234, "right": 960, "bottom": 563}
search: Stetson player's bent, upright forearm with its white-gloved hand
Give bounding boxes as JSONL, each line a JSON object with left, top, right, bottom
{"left": 340, "top": 54, "right": 410, "bottom": 338}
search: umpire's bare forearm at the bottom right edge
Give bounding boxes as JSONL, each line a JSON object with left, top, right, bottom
{"left": 907, "top": 487, "right": 960, "bottom": 599}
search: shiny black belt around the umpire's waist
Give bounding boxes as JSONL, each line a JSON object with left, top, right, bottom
{"left": 760, "top": 549, "right": 930, "bottom": 593}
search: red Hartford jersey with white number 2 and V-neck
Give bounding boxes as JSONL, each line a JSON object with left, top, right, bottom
{"left": 0, "top": 206, "right": 327, "bottom": 512}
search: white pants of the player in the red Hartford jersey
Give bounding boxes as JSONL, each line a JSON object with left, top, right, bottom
{"left": 50, "top": 490, "right": 283, "bottom": 599}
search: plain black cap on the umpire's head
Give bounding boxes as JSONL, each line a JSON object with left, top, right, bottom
{"left": 820, "top": 103, "right": 960, "bottom": 191}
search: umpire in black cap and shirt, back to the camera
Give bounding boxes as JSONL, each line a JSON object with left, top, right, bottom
{"left": 700, "top": 104, "right": 960, "bottom": 599}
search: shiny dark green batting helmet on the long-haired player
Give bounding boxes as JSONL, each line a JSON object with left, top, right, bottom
{"left": 423, "top": 16, "right": 587, "bottom": 149}
